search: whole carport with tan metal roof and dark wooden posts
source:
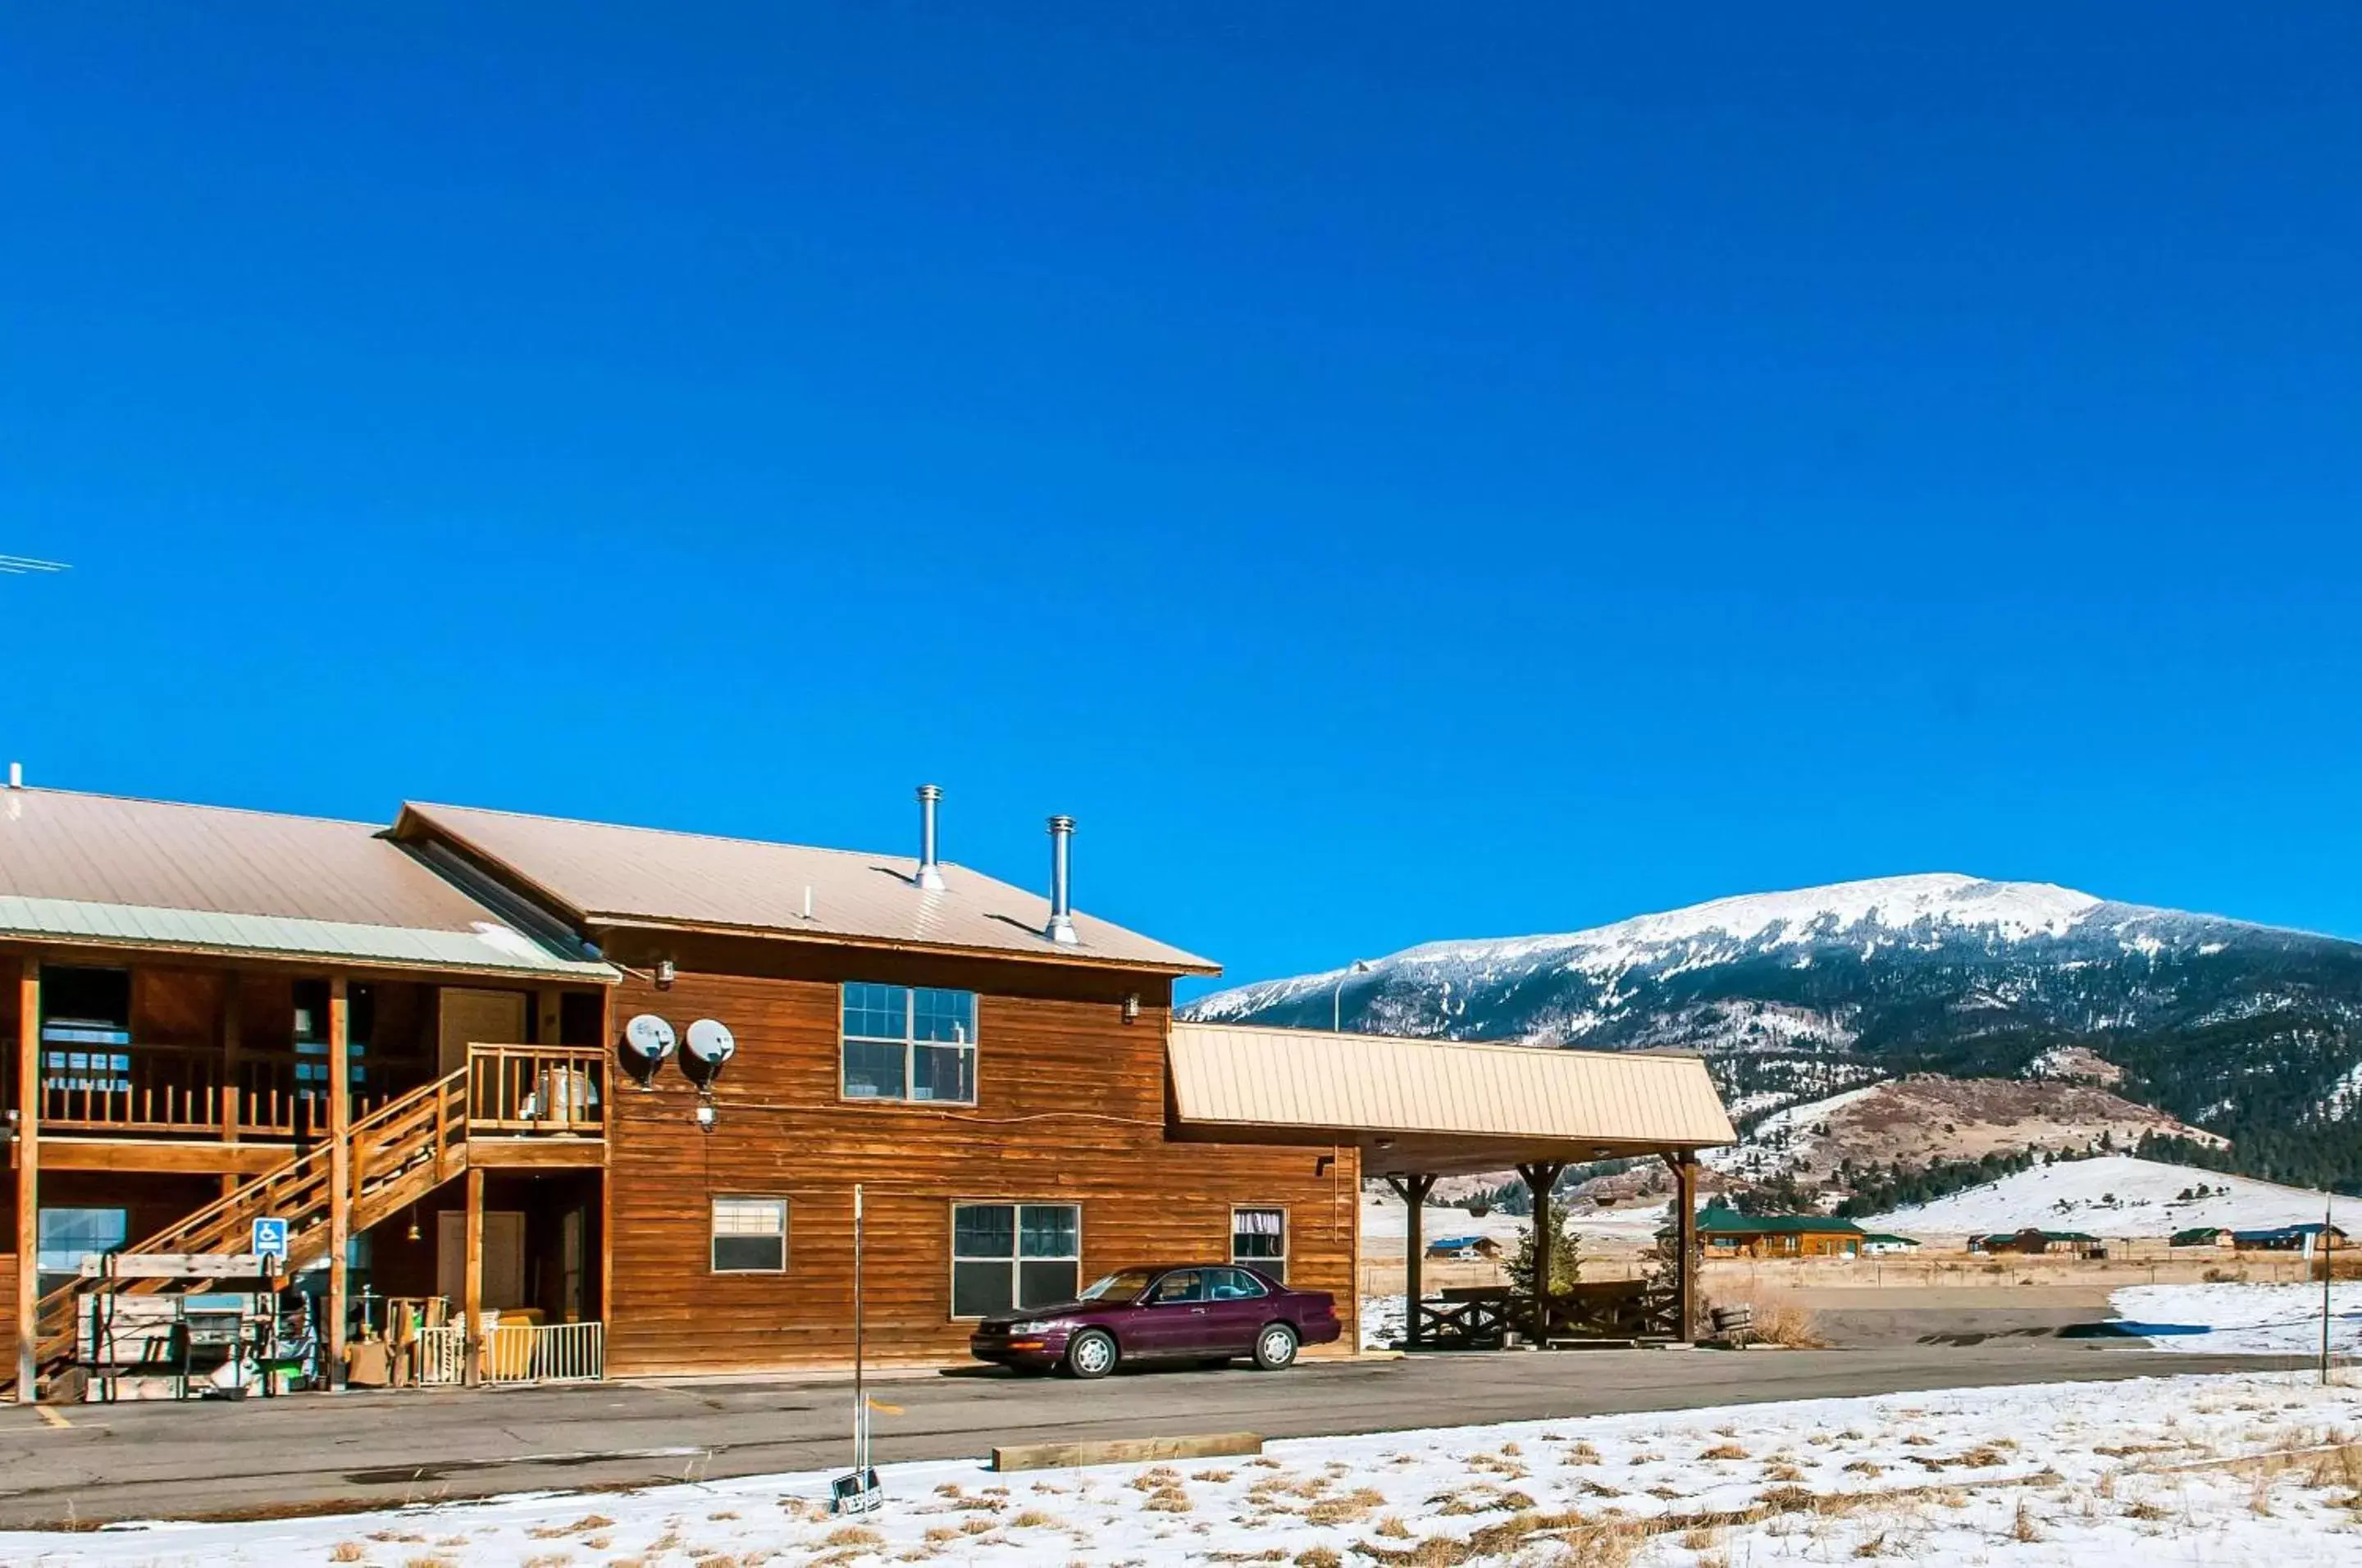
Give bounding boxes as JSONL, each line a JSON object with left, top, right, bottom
{"left": 1167, "top": 1023, "right": 1739, "bottom": 1346}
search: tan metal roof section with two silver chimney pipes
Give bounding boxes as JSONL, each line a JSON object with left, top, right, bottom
{"left": 394, "top": 803, "right": 1216, "bottom": 973}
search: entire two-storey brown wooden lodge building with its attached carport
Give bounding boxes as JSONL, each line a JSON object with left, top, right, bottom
{"left": 0, "top": 786, "right": 1731, "bottom": 1401}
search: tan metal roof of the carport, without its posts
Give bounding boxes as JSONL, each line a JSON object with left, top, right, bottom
{"left": 1167, "top": 1023, "right": 1739, "bottom": 1174}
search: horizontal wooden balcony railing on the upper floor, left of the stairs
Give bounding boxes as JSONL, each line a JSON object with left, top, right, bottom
{"left": 40, "top": 1044, "right": 392, "bottom": 1141}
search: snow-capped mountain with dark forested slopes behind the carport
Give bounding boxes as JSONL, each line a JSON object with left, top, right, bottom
{"left": 1183, "top": 873, "right": 2362, "bottom": 1183}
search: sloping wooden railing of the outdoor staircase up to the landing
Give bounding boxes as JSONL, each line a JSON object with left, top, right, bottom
{"left": 33, "top": 1068, "right": 467, "bottom": 1370}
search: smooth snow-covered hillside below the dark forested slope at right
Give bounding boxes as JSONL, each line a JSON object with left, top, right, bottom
{"left": 1863, "top": 1155, "right": 2352, "bottom": 1238}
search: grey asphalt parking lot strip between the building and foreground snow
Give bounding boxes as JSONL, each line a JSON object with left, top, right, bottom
{"left": 0, "top": 1337, "right": 2305, "bottom": 1528}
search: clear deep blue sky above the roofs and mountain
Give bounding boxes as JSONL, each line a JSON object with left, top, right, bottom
{"left": 0, "top": 0, "right": 2362, "bottom": 980}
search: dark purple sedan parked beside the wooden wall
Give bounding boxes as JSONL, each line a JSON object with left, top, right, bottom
{"left": 969, "top": 1264, "right": 1342, "bottom": 1377}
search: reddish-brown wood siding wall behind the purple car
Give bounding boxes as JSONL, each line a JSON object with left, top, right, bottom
{"left": 607, "top": 942, "right": 1358, "bottom": 1374}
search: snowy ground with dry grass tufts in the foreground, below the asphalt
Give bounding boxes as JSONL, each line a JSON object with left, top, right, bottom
{"left": 0, "top": 1374, "right": 2362, "bottom": 1568}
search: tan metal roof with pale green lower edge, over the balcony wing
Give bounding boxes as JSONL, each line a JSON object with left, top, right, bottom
{"left": 0, "top": 789, "right": 617, "bottom": 980}
